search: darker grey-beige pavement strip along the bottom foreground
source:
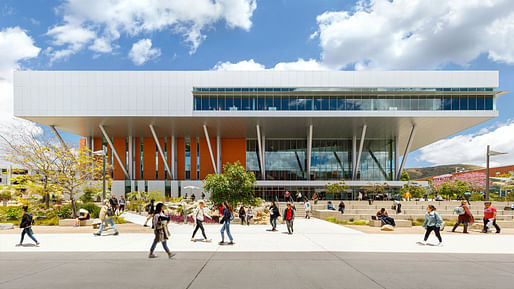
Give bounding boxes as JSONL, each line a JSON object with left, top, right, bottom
{"left": 0, "top": 252, "right": 514, "bottom": 289}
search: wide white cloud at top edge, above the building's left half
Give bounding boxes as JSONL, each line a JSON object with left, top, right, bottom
{"left": 48, "top": 0, "right": 257, "bottom": 59}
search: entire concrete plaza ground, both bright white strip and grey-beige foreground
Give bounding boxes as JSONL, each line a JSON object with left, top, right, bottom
{"left": 0, "top": 214, "right": 514, "bottom": 289}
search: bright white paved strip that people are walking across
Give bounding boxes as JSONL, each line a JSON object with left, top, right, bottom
{"left": 0, "top": 210, "right": 514, "bottom": 254}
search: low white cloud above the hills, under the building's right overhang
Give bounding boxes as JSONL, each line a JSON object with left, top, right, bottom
{"left": 417, "top": 120, "right": 514, "bottom": 167}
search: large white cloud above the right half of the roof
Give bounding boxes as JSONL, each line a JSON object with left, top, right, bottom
{"left": 312, "top": 0, "right": 514, "bottom": 69}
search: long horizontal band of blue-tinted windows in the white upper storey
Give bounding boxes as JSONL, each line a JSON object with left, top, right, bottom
{"left": 193, "top": 88, "right": 495, "bottom": 111}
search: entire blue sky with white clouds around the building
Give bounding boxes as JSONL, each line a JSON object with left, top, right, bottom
{"left": 0, "top": 0, "right": 514, "bottom": 167}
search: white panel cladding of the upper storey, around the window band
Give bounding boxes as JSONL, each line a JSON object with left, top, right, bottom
{"left": 14, "top": 71, "right": 498, "bottom": 116}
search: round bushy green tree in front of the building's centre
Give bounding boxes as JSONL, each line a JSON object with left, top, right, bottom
{"left": 203, "top": 161, "right": 257, "bottom": 207}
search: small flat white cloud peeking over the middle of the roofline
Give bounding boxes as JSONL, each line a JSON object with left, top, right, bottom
{"left": 212, "top": 58, "right": 329, "bottom": 71}
